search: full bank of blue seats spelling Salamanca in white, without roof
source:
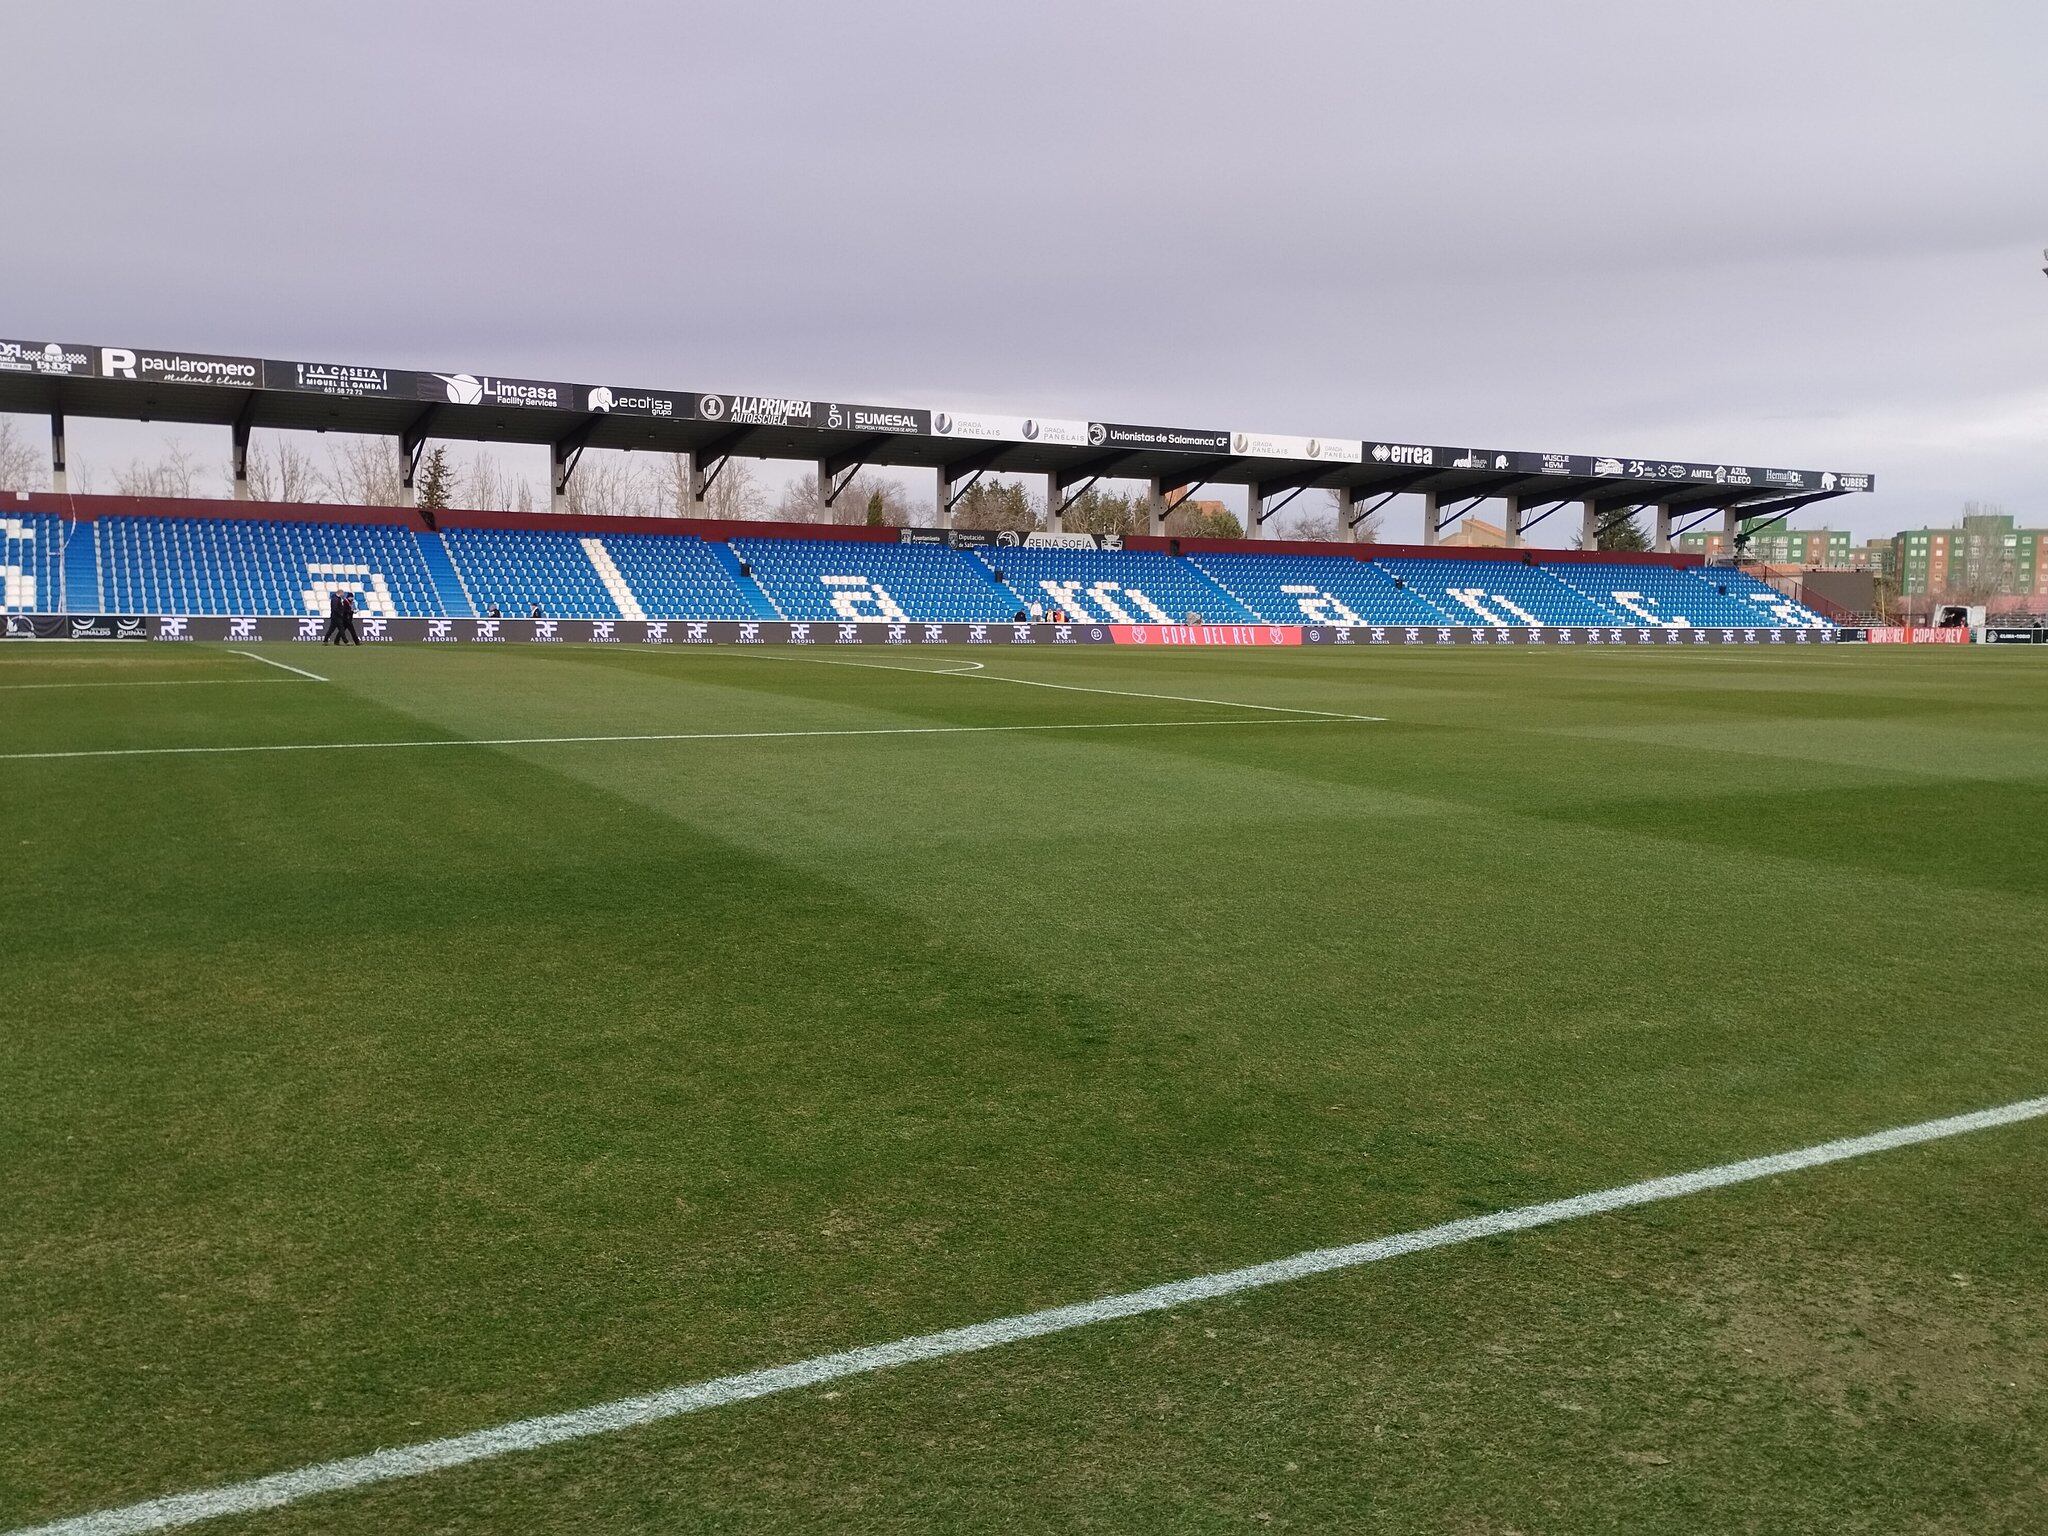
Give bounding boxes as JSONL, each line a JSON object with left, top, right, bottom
{"left": 4, "top": 496, "right": 1829, "bottom": 629}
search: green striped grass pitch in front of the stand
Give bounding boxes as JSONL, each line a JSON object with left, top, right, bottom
{"left": 0, "top": 645, "right": 2048, "bottom": 1536}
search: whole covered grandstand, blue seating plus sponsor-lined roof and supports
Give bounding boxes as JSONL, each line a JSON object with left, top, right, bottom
{"left": 0, "top": 340, "right": 1872, "bottom": 637}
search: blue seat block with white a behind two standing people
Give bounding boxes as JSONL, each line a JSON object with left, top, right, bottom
{"left": 98, "top": 516, "right": 440, "bottom": 618}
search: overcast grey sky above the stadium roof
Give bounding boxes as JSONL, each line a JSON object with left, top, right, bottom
{"left": 0, "top": 0, "right": 2048, "bottom": 537}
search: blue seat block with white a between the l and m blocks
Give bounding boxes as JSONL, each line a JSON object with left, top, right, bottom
{"left": 731, "top": 539, "right": 1024, "bottom": 623}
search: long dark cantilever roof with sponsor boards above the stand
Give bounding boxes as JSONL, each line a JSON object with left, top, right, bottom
{"left": 0, "top": 338, "right": 1876, "bottom": 510}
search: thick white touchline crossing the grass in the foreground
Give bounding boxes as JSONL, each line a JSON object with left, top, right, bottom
{"left": 8, "top": 1098, "right": 2048, "bottom": 1536}
